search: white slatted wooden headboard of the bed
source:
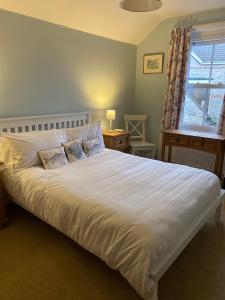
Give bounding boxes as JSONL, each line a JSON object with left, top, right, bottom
{"left": 0, "top": 112, "right": 91, "bottom": 132}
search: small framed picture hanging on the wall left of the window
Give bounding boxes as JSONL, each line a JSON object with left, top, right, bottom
{"left": 143, "top": 53, "right": 164, "bottom": 74}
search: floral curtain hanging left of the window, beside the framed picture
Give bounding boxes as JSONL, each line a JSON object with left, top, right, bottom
{"left": 162, "top": 27, "right": 191, "bottom": 129}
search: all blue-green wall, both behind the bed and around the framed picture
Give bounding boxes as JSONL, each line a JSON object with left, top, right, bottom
{"left": 0, "top": 9, "right": 225, "bottom": 138}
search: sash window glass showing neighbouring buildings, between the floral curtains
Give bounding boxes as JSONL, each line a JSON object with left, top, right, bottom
{"left": 180, "top": 40, "right": 225, "bottom": 131}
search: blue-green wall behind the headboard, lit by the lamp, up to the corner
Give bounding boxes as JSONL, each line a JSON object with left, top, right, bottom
{"left": 0, "top": 10, "right": 137, "bottom": 125}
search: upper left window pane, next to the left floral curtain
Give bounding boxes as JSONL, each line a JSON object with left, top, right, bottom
{"left": 188, "top": 44, "right": 213, "bottom": 83}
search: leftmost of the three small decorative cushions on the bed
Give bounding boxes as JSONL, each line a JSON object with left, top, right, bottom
{"left": 38, "top": 147, "right": 68, "bottom": 170}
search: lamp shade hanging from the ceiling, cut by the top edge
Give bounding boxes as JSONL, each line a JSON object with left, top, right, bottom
{"left": 120, "top": 0, "right": 162, "bottom": 12}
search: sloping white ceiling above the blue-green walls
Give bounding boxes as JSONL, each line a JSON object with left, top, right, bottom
{"left": 0, "top": 0, "right": 225, "bottom": 44}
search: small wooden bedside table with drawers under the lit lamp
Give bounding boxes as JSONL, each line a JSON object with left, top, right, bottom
{"left": 103, "top": 130, "right": 130, "bottom": 153}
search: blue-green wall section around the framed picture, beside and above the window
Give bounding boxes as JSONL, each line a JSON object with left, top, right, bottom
{"left": 135, "top": 9, "right": 225, "bottom": 152}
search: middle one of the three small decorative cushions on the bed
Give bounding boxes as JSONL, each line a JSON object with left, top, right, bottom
{"left": 63, "top": 140, "right": 87, "bottom": 162}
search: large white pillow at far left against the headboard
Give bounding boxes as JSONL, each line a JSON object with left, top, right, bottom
{"left": 2, "top": 130, "right": 61, "bottom": 170}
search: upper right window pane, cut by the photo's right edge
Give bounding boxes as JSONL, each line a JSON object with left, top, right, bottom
{"left": 211, "top": 43, "right": 225, "bottom": 84}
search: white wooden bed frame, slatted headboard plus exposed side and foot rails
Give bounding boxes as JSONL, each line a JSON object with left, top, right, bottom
{"left": 0, "top": 112, "right": 225, "bottom": 298}
